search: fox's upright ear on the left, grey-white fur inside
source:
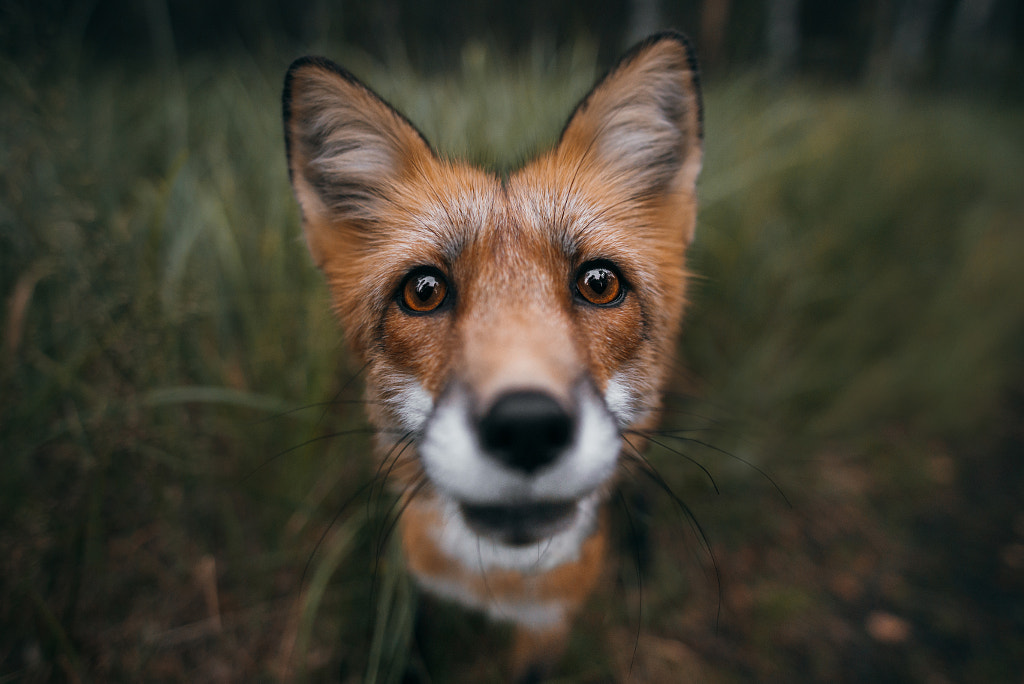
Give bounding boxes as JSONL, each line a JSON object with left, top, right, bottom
{"left": 282, "top": 57, "right": 433, "bottom": 268}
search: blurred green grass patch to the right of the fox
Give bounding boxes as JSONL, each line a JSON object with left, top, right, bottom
{"left": 687, "top": 81, "right": 1024, "bottom": 444}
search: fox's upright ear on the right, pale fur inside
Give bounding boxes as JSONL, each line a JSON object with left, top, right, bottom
{"left": 557, "top": 32, "right": 703, "bottom": 242}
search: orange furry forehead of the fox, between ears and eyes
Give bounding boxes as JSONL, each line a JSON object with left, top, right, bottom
{"left": 358, "top": 158, "right": 682, "bottom": 308}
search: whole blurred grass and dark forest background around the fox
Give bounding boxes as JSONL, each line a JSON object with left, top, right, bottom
{"left": 0, "top": 0, "right": 1024, "bottom": 684}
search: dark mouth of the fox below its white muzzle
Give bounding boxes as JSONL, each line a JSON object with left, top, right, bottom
{"left": 460, "top": 501, "right": 577, "bottom": 546}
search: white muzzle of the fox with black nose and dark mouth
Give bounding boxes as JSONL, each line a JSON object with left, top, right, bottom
{"left": 420, "top": 381, "right": 622, "bottom": 546}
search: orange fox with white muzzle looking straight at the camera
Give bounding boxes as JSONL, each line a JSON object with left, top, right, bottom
{"left": 283, "top": 31, "right": 703, "bottom": 681}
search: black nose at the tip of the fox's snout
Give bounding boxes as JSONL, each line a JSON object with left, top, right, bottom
{"left": 480, "top": 391, "right": 572, "bottom": 474}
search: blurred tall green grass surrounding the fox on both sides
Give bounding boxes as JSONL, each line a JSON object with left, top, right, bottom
{"left": 0, "top": 40, "right": 1024, "bottom": 681}
